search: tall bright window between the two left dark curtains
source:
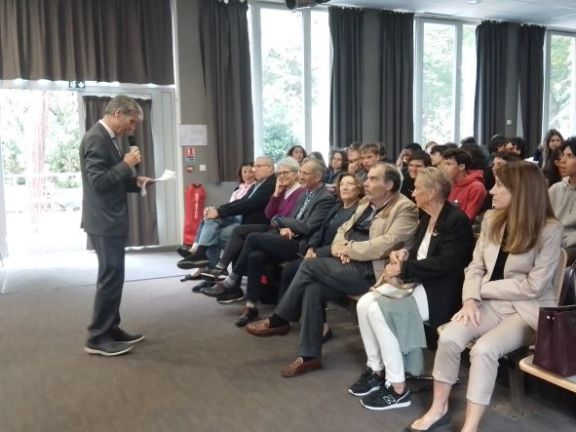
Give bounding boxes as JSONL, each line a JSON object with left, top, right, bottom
{"left": 250, "top": 3, "right": 331, "bottom": 160}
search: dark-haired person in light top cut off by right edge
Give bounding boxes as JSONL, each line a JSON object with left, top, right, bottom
{"left": 548, "top": 136, "right": 576, "bottom": 263}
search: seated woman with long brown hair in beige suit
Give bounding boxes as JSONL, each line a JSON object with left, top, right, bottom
{"left": 406, "top": 162, "right": 563, "bottom": 432}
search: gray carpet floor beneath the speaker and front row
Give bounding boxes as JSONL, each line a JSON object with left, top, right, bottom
{"left": 0, "top": 253, "right": 576, "bottom": 432}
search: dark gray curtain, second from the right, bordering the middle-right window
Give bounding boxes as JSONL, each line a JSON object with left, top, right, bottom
{"left": 474, "top": 21, "right": 508, "bottom": 144}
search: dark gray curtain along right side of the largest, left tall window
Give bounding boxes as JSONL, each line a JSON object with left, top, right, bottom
{"left": 328, "top": 7, "right": 362, "bottom": 148}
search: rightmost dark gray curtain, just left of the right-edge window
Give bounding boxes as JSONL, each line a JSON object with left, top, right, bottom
{"left": 518, "top": 25, "right": 546, "bottom": 154}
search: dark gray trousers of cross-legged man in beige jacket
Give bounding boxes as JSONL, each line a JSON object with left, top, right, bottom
{"left": 274, "top": 257, "right": 375, "bottom": 357}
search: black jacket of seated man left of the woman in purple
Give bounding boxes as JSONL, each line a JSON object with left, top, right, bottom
{"left": 218, "top": 175, "right": 276, "bottom": 225}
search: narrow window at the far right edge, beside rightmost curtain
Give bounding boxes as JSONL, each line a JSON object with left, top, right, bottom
{"left": 542, "top": 33, "right": 576, "bottom": 137}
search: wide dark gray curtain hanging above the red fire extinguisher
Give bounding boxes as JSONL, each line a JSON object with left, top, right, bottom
{"left": 199, "top": 0, "right": 252, "bottom": 181}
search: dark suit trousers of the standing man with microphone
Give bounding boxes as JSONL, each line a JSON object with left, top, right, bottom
{"left": 88, "top": 234, "right": 126, "bottom": 344}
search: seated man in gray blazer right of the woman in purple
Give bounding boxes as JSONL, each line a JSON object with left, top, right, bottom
{"left": 202, "top": 159, "right": 335, "bottom": 306}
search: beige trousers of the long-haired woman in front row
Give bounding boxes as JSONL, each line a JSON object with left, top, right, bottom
{"left": 433, "top": 300, "right": 534, "bottom": 405}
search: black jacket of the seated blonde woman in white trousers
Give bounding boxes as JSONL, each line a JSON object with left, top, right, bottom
{"left": 401, "top": 202, "right": 474, "bottom": 327}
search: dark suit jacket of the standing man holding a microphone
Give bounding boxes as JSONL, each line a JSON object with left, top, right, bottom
{"left": 80, "top": 123, "right": 140, "bottom": 236}
